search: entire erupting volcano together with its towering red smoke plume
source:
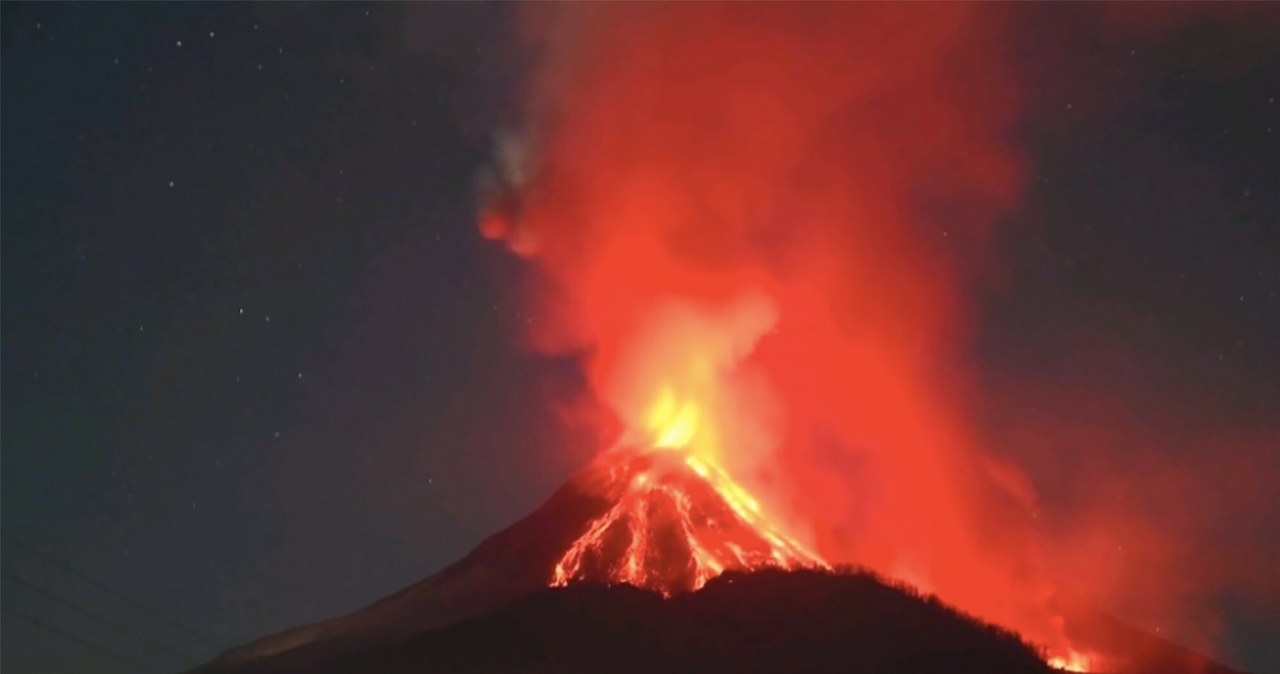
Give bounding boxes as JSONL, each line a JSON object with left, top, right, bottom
{"left": 185, "top": 4, "right": 1264, "bottom": 673}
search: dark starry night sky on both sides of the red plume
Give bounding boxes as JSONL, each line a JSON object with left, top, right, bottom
{"left": 0, "top": 4, "right": 1280, "bottom": 673}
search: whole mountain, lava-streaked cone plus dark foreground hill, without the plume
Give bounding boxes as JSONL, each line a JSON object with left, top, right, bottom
{"left": 196, "top": 448, "right": 1249, "bottom": 674}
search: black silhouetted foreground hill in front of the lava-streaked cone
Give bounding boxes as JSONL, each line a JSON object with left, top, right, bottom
{"left": 225, "top": 570, "right": 1052, "bottom": 674}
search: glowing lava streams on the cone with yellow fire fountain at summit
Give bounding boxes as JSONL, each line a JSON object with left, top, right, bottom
{"left": 550, "top": 394, "right": 827, "bottom": 595}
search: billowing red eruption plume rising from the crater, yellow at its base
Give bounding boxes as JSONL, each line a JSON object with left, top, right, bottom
{"left": 481, "top": 4, "right": 1090, "bottom": 670}
